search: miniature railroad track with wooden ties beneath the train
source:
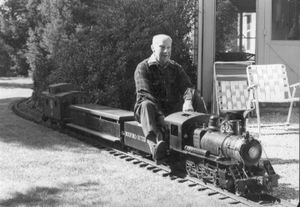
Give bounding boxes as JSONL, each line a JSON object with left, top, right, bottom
{"left": 67, "top": 130, "right": 296, "bottom": 207}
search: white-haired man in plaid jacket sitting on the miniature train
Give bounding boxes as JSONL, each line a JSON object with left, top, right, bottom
{"left": 134, "top": 34, "right": 206, "bottom": 161}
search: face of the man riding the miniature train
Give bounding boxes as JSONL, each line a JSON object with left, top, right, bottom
{"left": 151, "top": 38, "right": 172, "bottom": 65}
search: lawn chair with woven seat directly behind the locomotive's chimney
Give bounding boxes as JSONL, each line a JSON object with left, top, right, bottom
{"left": 213, "top": 61, "right": 253, "bottom": 133}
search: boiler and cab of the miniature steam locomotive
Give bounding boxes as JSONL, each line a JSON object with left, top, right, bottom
{"left": 166, "top": 112, "right": 262, "bottom": 166}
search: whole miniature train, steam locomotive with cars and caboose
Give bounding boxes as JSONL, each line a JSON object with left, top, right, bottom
{"left": 43, "top": 83, "right": 279, "bottom": 195}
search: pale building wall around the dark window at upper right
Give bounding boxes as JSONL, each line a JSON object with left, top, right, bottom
{"left": 256, "top": 0, "right": 300, "bottom": 96}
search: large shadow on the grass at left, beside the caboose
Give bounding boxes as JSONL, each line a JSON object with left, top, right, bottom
{"left": 0, "top": 98, "right": 106, "bottom": 152}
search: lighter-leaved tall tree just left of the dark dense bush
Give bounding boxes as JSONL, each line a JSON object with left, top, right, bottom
{"left": 26, "top": 0, "right": 78, "bottom": 100}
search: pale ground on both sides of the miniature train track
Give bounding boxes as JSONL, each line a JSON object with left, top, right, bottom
{"left": 0, "top": 78, "right": 299, "bottom": 207}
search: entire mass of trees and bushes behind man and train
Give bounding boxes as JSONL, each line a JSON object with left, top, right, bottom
{"left": 0, "top": 0, "right": 196, "bottom": 109}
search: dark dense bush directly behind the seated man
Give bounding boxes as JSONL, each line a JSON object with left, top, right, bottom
{"left": 51, "top": 0, "right": 196, "bottom": 109}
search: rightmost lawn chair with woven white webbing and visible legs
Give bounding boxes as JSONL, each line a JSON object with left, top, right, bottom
{"left": 247, "top": 64, "right": 300, "bottom": 135}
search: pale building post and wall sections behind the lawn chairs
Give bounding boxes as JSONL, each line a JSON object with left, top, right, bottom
{"left": 197, "top": 0, "right": 300, "bottom": 109}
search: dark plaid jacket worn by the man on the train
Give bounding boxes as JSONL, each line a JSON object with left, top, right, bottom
{"left": 134, "top": 58, "right": 192, "bottom": 115}
